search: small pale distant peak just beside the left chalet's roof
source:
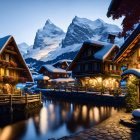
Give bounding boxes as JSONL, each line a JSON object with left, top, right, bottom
{"left": 18, "top": 42, "right": 33, "bottom": 56}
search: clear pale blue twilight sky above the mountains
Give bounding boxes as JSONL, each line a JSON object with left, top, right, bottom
{"left": 0, "top": 0, "right": 122, "bottom": 45}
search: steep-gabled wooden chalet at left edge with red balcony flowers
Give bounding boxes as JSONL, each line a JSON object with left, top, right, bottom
{"left": 0, "top": 36, "right": 33, "bottom": 94}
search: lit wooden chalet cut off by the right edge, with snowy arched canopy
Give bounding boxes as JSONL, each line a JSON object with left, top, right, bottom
{"left": 114, "top": 24, "right": 140, "bottom": 102}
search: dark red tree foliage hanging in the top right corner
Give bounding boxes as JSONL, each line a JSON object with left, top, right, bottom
{"left": 107, "top": 0, "right": 140, "bottom": 37}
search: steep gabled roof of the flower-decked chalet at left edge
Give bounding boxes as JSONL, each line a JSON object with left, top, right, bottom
{"left": 0, "top": 35, "right": 33, "bottom": 82}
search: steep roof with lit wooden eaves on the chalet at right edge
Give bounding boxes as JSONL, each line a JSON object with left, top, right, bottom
{"left": 114, "top": 24, "right": 140, "bottom": 61}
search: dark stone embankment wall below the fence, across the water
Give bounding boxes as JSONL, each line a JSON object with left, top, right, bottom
{"left": 35, "top": 89, "right": 125, "bottom": 107}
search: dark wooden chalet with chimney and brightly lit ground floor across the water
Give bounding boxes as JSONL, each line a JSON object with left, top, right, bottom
{"left": 67, "top": 35, "right": 121, "bottom": 89}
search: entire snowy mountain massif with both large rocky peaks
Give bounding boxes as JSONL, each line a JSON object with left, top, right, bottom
{"left": 26, "top": 16, "right": 123, "bottom": 63}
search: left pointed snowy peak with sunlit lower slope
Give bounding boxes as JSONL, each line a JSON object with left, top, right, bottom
{"left": 24, "top": 19, "right": 65, "bottom": 61}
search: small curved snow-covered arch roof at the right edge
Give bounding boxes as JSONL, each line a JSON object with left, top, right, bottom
{"left": 121, "top": 68, "right": 140, "bottom": 78}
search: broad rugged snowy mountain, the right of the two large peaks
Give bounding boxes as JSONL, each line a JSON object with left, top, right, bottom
{"left": 62, "top": 16, "right": 121, "bottom": 48}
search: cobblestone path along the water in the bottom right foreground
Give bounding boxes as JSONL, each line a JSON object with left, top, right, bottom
{"left": 59, "top": 112, "right": 140, "bottom": 140}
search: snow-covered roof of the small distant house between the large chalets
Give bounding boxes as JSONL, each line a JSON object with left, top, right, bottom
{"left": 42, "top": 65, "right": 71, "bottom": 73}
